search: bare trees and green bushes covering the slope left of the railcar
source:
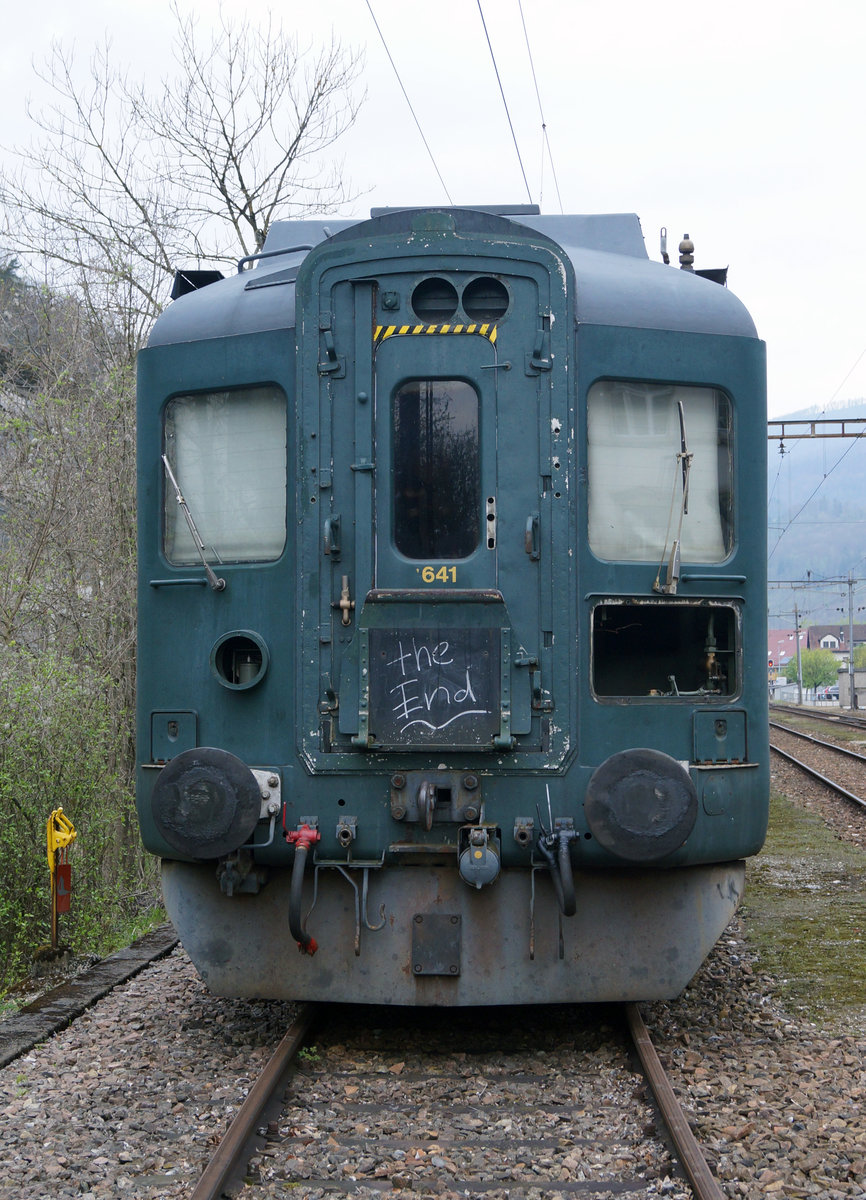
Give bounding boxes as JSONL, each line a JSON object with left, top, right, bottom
{"left": 0, "top": 8, "right": 361, "bottom": 991}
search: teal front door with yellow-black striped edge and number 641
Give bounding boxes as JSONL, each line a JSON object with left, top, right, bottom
{"left": 302, "top": 232, "right": 567, "bottom": 766}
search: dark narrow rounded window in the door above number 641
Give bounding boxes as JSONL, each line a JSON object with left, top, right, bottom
{"left": 392, "top": 379, "right": 480, "bottom": 559}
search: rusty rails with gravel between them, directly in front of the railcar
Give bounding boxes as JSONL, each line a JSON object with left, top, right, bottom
{"left": 192, "top": 1004, "right": 722, "bottom": 1200}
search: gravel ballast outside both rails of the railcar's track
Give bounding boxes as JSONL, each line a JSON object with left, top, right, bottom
{"left": 0, "top": 925, "right": 866, "bottom": 1200}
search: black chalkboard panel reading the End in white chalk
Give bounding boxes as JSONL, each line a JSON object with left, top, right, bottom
{"left": 369, "top": 628, "right": 500, "bottom": 749}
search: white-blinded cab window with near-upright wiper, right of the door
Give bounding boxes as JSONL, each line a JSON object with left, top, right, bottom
{"left": 587, "top": 379, "right": 733, "bottom": 563}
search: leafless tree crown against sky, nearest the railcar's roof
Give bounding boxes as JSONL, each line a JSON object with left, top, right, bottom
{"left": 138, "top": 10, "right": 359, "bottom": 257}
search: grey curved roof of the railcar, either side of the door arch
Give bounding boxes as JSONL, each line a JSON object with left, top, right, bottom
{"left": 149, "top": 205, "right": 757, "bottom": 346}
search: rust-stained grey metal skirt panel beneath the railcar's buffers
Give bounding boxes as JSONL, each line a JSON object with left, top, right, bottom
{"left": 162, "top": 862, "right": 745, "bottom": 1006}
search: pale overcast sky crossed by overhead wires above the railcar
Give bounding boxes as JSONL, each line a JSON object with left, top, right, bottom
{"left": 0, "top": 0, "right": 866, "bottom": 415}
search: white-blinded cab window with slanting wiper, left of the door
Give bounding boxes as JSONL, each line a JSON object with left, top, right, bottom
{"left": 163, "top": 386, "right": 287, "bottom": 565}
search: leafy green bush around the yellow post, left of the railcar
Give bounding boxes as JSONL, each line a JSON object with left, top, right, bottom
{"left": 0, "top": 644, "right": 158, "bottom": 990}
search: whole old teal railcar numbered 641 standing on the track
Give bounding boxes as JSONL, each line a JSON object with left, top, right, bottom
{"left": 138, "top": 208, "right": 769, "bottom": 1006}
